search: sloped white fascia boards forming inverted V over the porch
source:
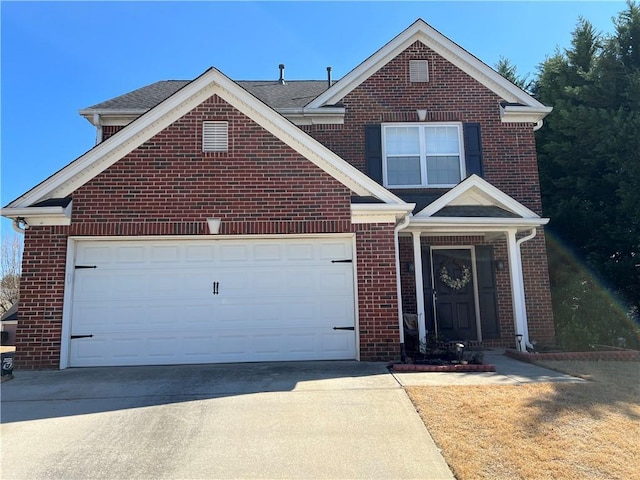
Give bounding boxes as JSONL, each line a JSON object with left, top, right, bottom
{"left": 415, "top": 174, "right": 540, "bottom": 220}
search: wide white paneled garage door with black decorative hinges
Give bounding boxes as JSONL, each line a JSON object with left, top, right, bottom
{"left": 69, "top": 238, "right": 356, "bottom": 366}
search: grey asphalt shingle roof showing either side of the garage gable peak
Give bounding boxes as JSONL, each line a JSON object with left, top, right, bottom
{"left": 83, "top": 80, "right": 327, "bottom": 111}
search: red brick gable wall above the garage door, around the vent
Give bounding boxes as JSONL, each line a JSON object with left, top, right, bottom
{"left": 73, "top": 96, "right": 351, "bottom": 227}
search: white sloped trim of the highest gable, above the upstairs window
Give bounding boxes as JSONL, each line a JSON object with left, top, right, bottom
{"left": 307, "top": 19, "right": 551, "bottom": 117}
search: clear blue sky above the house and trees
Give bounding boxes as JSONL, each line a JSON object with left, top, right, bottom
{"left": 0, "top": 0, "right": 625, "bottom": 234}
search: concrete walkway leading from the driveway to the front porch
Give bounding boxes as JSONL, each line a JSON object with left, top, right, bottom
{"left": 393, "top": 350, "right": 585, "bottom": 387}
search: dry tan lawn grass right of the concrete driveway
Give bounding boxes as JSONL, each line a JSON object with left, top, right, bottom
{"left": 407, "top": 361, "right": 640, "bottom": 480}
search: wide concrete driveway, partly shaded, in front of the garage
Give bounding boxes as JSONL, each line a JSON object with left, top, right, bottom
{"left": 0, "top": 362, "right": 453, "bottom": 480}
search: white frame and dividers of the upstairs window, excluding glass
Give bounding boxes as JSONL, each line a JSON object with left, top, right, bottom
{"left": 381, "top": 122, "right": 467, "bottom": 189}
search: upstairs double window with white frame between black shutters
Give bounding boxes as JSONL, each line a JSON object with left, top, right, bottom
{"left": 382, "top": 123, "right": 465, "bottom": 188}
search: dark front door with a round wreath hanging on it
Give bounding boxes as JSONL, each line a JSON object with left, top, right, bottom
{"left": 431, "top": 249, "right": 478, "bottom": 341}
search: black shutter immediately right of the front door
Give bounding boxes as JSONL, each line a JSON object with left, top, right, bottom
{"left": 476, "top": 245, "right": 500, "bottom": 340}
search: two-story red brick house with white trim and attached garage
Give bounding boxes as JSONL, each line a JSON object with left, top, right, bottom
{"left": 2, "top": 20, "right": 554, "bottom": 368}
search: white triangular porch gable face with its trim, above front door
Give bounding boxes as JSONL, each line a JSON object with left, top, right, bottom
{"left": 415, "top": 174, "right": 540, "bottom": 221}
